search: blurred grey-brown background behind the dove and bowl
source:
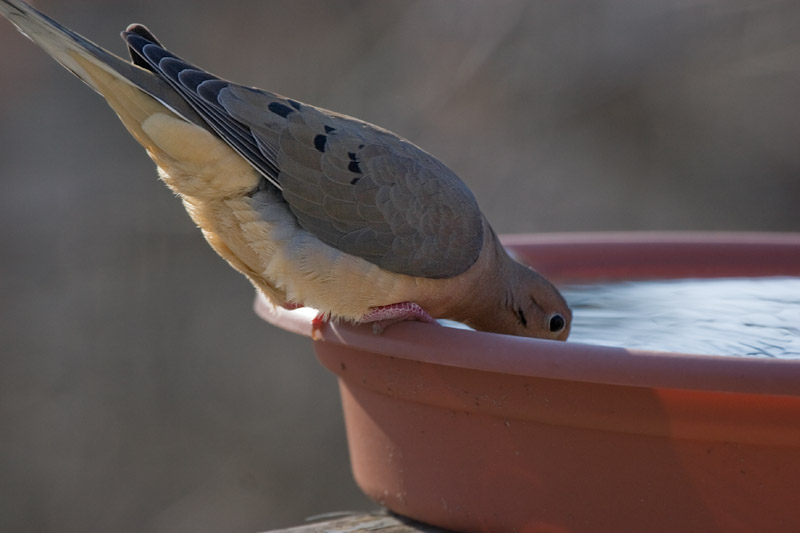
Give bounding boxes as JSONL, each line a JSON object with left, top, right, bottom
{"left": 0, "top": 0, "right": 800, "bottom": 533}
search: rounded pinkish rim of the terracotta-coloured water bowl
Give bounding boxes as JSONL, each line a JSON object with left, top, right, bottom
{"left": 255, "top": 232, "right": 800, "bottom": 397}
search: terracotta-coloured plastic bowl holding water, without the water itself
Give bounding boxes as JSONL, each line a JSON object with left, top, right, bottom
{"left": 257, "top": 233, "right": 800, "bottom": 532}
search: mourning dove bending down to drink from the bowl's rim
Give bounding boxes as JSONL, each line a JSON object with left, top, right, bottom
{"left": 0, "top": 0, "right": 572, "bottom": 340}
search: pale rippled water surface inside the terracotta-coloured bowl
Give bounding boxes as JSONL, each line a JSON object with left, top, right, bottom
{"left": 562, "top": 277, "right": 800, "bottom": 358}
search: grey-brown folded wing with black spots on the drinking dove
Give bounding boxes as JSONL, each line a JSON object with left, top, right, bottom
{"left": 123, "top": 25, "right": 483, "bottom": 278}
